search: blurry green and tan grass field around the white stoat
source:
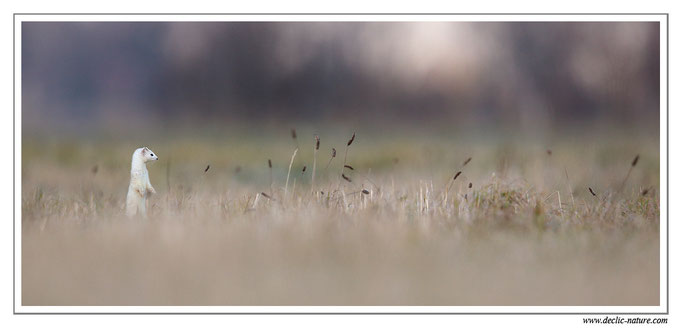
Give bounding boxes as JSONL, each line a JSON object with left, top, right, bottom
{"left": 21, "top": 128, "right": 661, "bottom": 305}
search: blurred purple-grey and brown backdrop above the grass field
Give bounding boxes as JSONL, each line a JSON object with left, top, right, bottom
{"left": 21, "top": 22, "right": 660, "bottom": 136}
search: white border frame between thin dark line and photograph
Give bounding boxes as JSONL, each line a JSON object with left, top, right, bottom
{"left": 14, "top": 13, "right": 669, "bottom": 315}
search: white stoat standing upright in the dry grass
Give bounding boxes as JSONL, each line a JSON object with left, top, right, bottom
{"left": 126, "top": 147, "right": 159, "bottom": 217}
